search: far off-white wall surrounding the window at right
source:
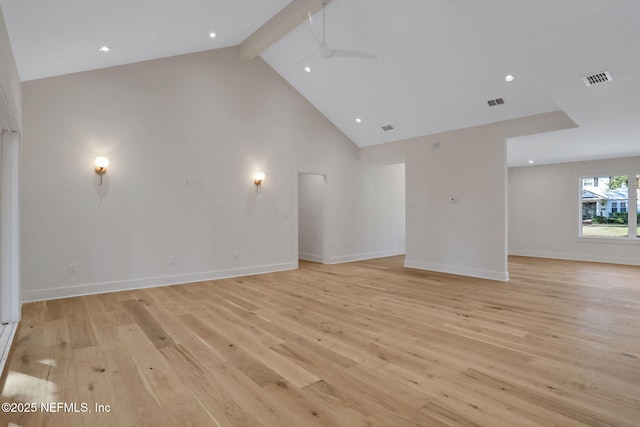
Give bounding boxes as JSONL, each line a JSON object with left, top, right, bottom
{"left": 509, "top": 157, "right": 640, "bottom": 265}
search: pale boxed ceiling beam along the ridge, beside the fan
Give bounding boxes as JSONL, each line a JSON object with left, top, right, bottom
{"left": 240, "top": 0, "right": 331, "bottom": 59}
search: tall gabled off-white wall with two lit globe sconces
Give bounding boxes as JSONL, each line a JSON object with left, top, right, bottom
{"left": 22, "top": 48, "right": 399, "bottom": 300}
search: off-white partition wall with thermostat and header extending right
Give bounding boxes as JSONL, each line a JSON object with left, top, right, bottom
{"left": 360, "top": 111, "right": 575, "bottom": 280}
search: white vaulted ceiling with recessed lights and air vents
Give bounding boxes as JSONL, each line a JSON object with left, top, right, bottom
{"left": 0, "top": 0, "right": 640, "bottom": 166}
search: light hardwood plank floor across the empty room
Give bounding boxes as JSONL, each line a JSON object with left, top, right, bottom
{"left": 0, "top": 257, "right": 640, "bottom": 427}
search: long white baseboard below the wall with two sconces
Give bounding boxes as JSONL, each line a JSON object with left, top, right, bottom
{"left": 22, "top": 262, "right": 296, "bottom": 302}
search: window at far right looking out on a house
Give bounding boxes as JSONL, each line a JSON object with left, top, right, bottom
{"left": 579, "top": 173, "right": 640, "bottom": 240}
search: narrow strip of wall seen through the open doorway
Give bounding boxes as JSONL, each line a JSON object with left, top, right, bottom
{"left": 298, "top": 173, "right": 325, "bottom": 262}
